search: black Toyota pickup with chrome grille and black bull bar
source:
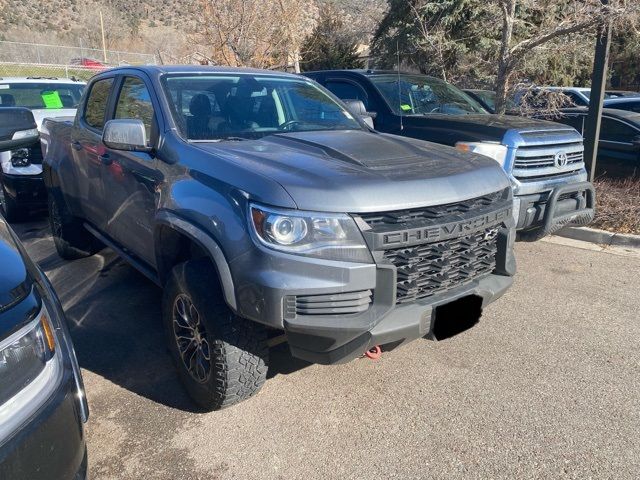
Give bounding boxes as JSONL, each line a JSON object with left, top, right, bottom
{"left": 305, "top": 70, "right": 595, "bottom": 240}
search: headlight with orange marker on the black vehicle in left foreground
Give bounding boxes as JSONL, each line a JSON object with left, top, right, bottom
{"left": 0, "top": 307, "right": 62, "bottom": 441}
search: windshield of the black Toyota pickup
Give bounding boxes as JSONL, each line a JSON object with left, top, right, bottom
{"left": 369, "top": 75, "right": 487, "bottom": 115}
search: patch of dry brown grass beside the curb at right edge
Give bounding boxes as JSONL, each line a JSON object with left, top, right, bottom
{"left": 590, "top": 177, "right": 640, "bottom": 234}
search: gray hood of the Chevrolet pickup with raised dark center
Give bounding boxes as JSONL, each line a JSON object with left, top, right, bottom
{"left": 194, "top": 130, "right": 510, "bottom": 213}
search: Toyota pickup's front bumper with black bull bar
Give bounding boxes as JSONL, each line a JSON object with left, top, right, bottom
{"left": 514, "top": 172, "right": 595, "bottom": 236}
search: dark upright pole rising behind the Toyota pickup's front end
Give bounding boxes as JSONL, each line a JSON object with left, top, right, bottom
{"left": 584, "top": 0, "right": 611, "bottom": 182}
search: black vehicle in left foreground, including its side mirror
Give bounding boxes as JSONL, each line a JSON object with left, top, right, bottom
{"left": 0, "top": 108, "right": 89, "bottom": 480}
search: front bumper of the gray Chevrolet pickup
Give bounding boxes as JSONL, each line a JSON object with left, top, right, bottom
{"left": 229, "top": 210, "right": 515, "bottom": 364}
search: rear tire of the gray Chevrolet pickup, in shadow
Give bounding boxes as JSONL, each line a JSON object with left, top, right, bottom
{"left": 48, "top": 193, "right": 104, "bottom": 260}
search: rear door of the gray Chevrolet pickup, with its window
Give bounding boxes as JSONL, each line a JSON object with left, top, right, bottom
{"left": 71, "top": 77, "right": 115, "bottom": 228}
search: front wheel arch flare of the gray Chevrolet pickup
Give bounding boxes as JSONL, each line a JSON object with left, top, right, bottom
{"left": 154, "top": 211, "right": 237, "bottom": 312}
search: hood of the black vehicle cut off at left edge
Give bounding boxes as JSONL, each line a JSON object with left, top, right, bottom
{"left": 0, "top": 218, "right": 31, "bottom": 312}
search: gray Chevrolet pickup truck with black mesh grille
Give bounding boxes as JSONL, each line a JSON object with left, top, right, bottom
{"left": 42, "top": 66, "right": 515, "bottom": 409}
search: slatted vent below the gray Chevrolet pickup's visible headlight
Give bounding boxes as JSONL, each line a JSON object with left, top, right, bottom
{"left": 284, "top": 290, "right": 373, "bottom": 319}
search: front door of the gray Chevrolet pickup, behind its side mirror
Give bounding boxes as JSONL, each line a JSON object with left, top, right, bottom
{"left": 102, "top": 74, "right": 162, "bottom": 266}
